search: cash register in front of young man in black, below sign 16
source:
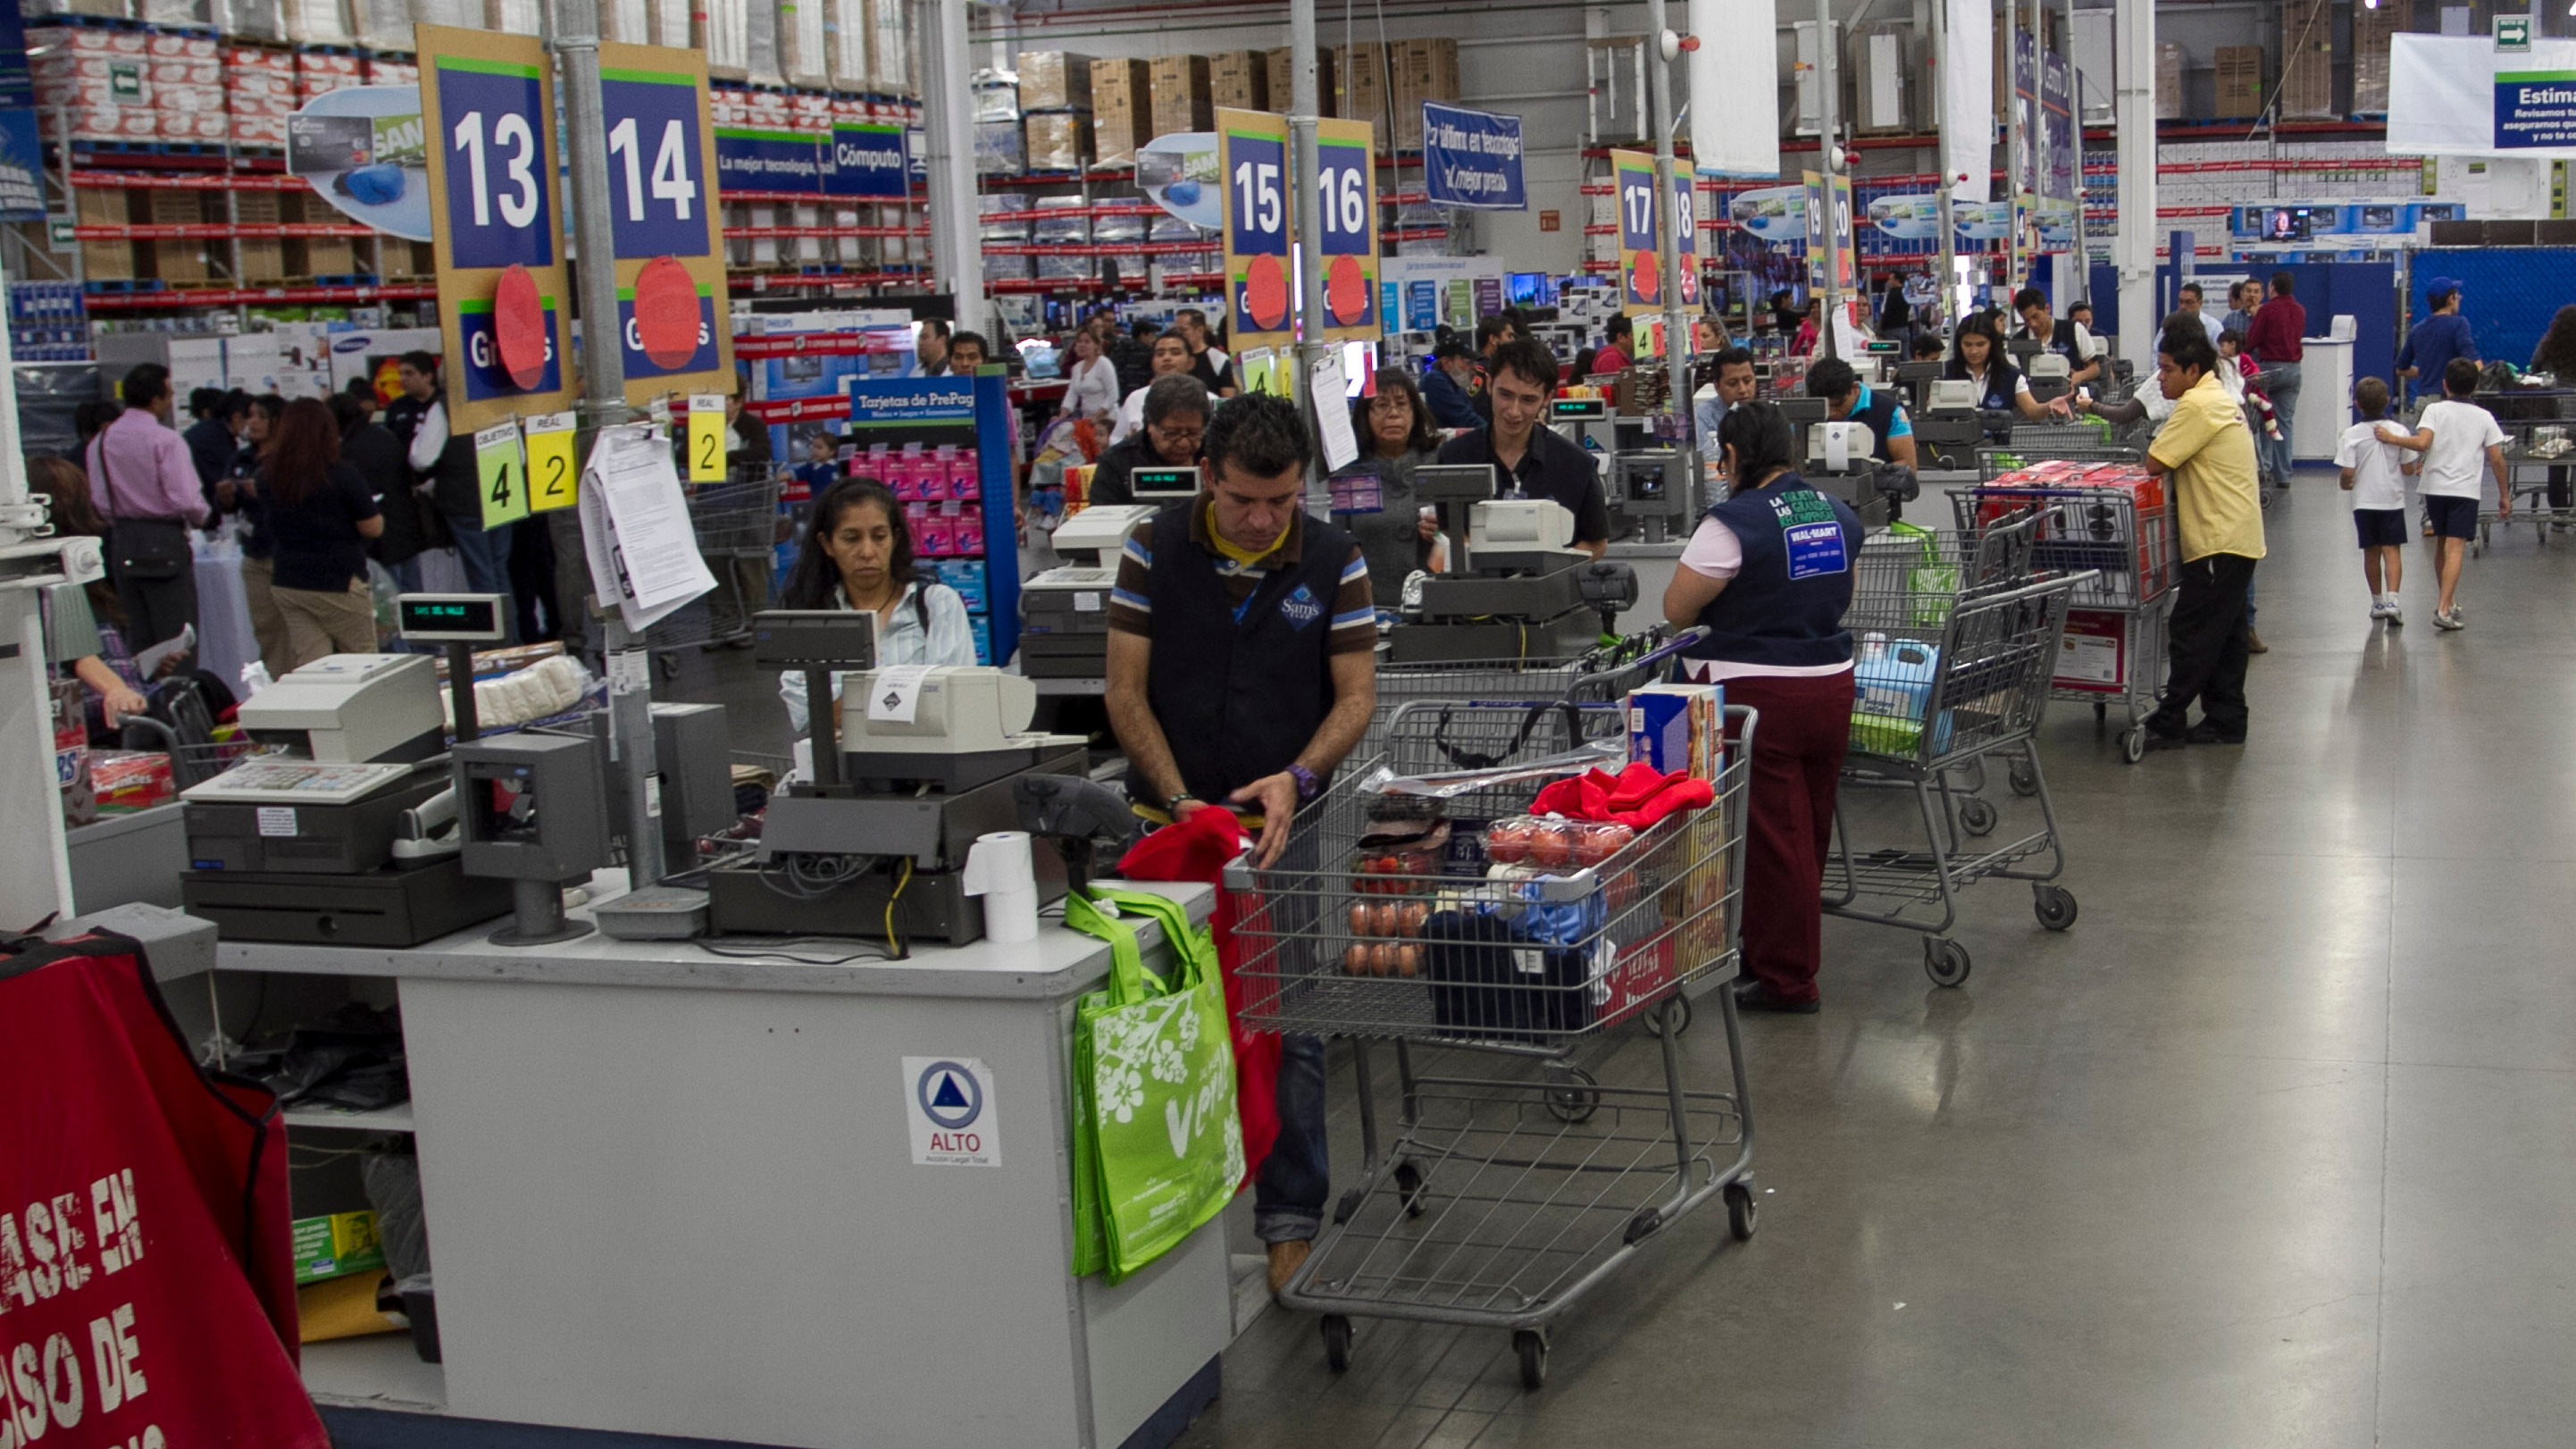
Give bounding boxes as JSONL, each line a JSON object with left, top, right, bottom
{"left": 1388, "top": 465, "right": 1635, "bottom": 666}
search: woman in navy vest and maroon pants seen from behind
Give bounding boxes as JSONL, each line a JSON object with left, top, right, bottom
{"left": 1664, "top": 402, "right": 1860, "bottom": 1013}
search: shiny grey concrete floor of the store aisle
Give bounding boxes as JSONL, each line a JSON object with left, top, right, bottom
{"left": 1185, "top": 484, "right": 2576, "bottom": 1449}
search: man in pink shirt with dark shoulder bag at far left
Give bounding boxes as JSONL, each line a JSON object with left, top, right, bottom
{"left": 88, "top": 364, "right": 206, "bottom": 649}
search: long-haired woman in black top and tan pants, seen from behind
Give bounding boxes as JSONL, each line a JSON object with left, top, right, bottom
{"left": 257, "top": 397, "right": 384, "bottom": 670}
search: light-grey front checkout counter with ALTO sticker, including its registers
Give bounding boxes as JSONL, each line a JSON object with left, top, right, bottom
{"left": 129, "top": 595, "right": 1234, "bottom": 1449}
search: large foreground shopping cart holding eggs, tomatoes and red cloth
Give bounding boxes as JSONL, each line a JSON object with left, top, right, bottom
{"left": 1226, "top": 701, "right": 1757, "bottom": 1390}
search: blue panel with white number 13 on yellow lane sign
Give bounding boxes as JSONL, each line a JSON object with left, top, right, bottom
{"left": 435, "top": 56, "right": 554, "bottom": 268}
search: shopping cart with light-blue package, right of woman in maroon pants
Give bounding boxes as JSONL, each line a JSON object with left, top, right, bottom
{"left": 1824, "top": 518, "right": 2092, "bottom": 984}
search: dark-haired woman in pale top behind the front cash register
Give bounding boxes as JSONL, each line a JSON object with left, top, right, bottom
{"left": 778, "top": 477, "right": 976, "bottom": 735}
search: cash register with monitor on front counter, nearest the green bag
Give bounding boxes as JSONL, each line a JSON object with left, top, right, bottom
{"left": 706, "top": 611, "right": 1087, "bottom": 957}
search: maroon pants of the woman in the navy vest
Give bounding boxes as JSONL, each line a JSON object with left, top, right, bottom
{"left": 1726, "top": 670, "right": 1853, "bottom": 1001}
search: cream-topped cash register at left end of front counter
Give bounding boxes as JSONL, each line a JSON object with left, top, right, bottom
{"left": 180, "top": 613, "right": 510, "bottom": 946}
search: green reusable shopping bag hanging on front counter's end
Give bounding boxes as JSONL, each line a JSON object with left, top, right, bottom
{"left": 1064, "top": 890, "right": 1244, "bottom": 1284}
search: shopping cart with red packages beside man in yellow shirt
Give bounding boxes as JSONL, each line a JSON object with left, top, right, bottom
{"left": 1950, "top": 482, "right": 2177, "bottom": 768}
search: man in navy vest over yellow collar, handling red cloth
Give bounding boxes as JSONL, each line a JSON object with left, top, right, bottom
{"left": 1108, "top": 395, "right": 1378, "bottom": 1294}
